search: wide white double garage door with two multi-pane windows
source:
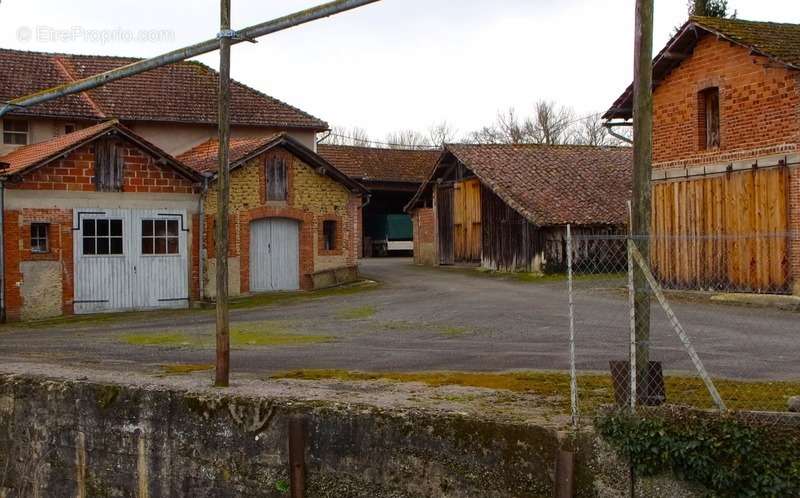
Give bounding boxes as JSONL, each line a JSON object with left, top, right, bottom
{"left": 73, "top": 209, "right": 189, "bottom": 313}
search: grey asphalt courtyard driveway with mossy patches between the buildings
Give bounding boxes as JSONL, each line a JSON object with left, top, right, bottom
{"left": 0, "top": 259, "right": 800, "bottom": 379}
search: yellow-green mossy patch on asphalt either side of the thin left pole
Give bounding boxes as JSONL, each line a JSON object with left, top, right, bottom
{"left": 121, "top": 322, "right": 334, "bottom": 349}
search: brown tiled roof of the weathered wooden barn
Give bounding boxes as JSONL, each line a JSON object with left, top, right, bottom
{"left": 408, "top": 144, "right": 633, "bottom": 226}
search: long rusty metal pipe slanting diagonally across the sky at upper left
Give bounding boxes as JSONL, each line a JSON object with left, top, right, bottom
{"left": 0, "top": 0, "right": 380, "bottom": 117}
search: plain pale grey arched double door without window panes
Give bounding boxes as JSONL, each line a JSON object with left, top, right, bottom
{"left": 250, "top": 218, "right": 300, "bottom": 292}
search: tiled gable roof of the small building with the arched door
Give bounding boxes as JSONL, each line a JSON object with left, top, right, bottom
{"left": 178, "top": 133, "right": 368, "bottom": 194}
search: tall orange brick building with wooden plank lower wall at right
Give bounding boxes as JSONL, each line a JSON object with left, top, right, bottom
{"left": 604, "top": 17, "right": 800, "bottom": 294}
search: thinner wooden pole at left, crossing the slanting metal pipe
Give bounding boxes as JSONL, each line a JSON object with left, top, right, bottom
{"left": 214, "top": 0, "right": 232, "bottom": 387}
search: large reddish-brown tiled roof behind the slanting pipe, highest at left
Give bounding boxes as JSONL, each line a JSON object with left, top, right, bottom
{"left": 0, "top": 49, "right": 328, "bottom": 130}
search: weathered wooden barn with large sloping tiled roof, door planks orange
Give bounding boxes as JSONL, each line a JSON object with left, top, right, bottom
{"left": 407, "top": 144, "right": 632, "bottom": 272}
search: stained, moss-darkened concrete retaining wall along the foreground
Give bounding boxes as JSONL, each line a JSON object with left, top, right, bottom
{"left": 0, "top": 375, "right": 559, "bottom": 498}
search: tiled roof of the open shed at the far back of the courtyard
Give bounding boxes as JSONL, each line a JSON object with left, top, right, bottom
{"left": 317, "top": 145, "right": 441, "bottom": 183}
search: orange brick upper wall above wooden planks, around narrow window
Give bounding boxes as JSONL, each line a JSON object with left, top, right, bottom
{"left": 653, "top": 36, "right": 800, "bottom": 167}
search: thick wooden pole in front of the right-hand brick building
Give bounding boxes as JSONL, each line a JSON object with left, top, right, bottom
{"left": 631, "top": 0, "right": 653, "bottom": 399}
